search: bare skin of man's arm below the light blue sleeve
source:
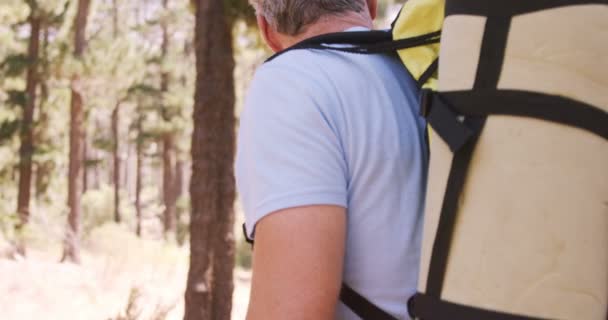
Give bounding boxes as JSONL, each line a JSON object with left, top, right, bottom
{"left": 247, "top": 206, "right": 346, "bottom": 320}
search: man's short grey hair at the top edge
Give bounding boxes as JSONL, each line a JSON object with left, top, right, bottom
{"left": 249, "top": 0, "right": 365, "bottom": 36}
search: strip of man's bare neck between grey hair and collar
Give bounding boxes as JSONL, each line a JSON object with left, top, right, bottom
{"left": 281, "top": 11, "right": 373, "bottom": 48}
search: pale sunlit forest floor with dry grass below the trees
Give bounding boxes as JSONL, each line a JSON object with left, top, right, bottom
{"left": 0, "top": 222, "right": 251, "bottom": 320}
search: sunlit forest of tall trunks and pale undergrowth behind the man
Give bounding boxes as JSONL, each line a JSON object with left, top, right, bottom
{"left": 0, "top": 0, "right": 399, "bottom": 320}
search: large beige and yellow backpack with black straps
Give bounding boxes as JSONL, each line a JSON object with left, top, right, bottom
{"left": 243, "top": 0, "right": 608, "bottom": 320}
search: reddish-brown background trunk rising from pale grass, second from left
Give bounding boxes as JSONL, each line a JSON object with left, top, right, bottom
{"left": 61, "top": 0, "right": 90, "bottom": 263}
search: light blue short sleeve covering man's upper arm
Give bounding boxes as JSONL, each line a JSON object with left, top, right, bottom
{"left": 235, "top": 65, "right": 348, "bottom": 237}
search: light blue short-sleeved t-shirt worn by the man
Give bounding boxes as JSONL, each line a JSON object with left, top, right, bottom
{"left": 235, "top": 28, "right": 426, "bottom": 320}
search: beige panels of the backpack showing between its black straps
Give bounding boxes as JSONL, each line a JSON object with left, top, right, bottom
{"left": 419, "top": 6, "right": 608, "bottom": 320}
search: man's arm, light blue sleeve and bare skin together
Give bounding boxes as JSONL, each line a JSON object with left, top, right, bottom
{"left": 235, "top": 62, "right": 348, "bottom": 320}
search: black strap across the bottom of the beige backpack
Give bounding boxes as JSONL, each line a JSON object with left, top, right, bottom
{"left": 408, "top": 293, "right": 544, "bottom": 320}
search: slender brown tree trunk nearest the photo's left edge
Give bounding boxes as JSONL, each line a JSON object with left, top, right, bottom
{"left": 17, "top": 12, "right": 40, "bottom": 231}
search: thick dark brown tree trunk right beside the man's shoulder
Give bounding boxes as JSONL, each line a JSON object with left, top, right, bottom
{"left": 184, "top": 0, "right": 235, "bottom": 320}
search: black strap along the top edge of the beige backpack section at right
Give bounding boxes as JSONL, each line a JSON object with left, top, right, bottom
{"left": 445, "top": 0, "right": 608, "bottom": 17}
